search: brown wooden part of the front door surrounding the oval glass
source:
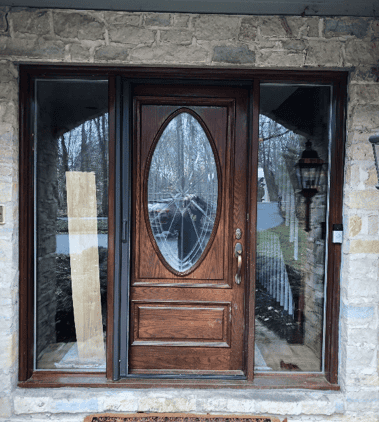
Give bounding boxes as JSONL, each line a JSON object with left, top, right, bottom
{"left": 129, "top": 85, "right": 248, "bottom": 375}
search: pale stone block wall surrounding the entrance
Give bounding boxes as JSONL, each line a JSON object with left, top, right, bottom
{"left": 0, "top": 8, "right": 379, "bottom": 422}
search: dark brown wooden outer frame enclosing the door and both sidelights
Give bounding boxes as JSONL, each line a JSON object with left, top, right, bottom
{"left": 18, "top": 64, "right": 349, "bottom": 390}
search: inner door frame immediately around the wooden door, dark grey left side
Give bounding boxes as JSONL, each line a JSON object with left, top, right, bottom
{"left": 112, "top": 77, "right": 255, "bottom": 380}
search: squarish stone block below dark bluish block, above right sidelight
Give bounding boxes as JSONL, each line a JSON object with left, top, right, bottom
{"left": 305, "top": 40, "right": 342, "bottom": 67}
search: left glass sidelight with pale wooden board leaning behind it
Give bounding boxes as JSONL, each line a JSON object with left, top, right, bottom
{"left": 34, "top": 80, "right": 108, "bottom": 371}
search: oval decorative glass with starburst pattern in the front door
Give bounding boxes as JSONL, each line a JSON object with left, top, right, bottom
{"left": 148, "top": 112, "right": 218, "bottom": 272}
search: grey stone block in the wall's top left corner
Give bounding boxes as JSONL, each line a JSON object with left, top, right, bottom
{"left": 10, "top": 9, "right": 50, "bottom": 35}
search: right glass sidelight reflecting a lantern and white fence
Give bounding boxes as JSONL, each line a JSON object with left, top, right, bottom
{"left": 255, "top": 84, "right": 331, "bottom": 372}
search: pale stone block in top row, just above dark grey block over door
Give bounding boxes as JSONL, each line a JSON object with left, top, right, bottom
{"left": 193, "top": 15, "right": 239, "bottom": 41}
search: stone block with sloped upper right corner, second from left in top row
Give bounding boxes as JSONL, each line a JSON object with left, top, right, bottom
{"left": 53, "top": 12, "right": 105, "bottom": 40}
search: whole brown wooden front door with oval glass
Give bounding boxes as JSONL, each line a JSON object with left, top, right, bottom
{"left": 129, "top": 85, "right": 248, "bottom": 375}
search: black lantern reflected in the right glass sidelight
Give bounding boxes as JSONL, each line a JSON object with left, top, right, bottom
{"left": 295, "top": 140, "right": 324, "bottom": 232}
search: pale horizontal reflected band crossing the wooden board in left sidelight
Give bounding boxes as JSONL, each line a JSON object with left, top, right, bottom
{"left": 56, "top": 234, "right": 108, "bottom": 255}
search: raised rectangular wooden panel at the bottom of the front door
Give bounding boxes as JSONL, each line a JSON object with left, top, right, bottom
{"left": 133, "top": 303, "right": 230, "bottom": 347}
